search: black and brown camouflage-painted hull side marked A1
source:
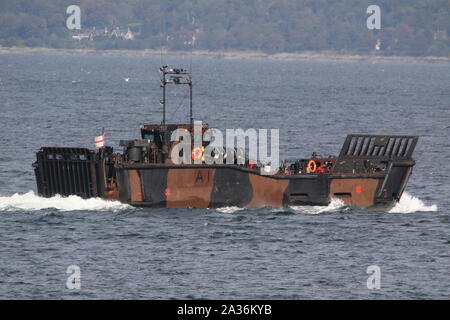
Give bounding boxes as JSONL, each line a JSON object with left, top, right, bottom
{"left": 111, "top": 165, "right": 408, "bottom": 210}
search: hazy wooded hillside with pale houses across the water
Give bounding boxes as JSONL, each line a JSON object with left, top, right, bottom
{"left": 0, "top": 0, "right": 450, "bottom": 56}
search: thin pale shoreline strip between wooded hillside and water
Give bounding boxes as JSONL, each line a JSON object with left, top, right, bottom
{"left": 0, "top": 46, "right": 450, "bottom": 63}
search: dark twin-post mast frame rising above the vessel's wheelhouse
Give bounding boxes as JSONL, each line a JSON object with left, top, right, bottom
{"left": 159, "top": 66, "right": 194, "bottom": 126}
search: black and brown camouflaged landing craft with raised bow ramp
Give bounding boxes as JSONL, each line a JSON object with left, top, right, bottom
{"left": 33, "top": 66, "right": 418, "bottom": 210}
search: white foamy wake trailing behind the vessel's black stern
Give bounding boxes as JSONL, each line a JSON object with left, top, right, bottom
{"left": 0, "top": 191, "right": 131, "bottom": 211}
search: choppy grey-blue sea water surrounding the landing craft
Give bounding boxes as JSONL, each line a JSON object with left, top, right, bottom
{"left": 0, "top": 55, "right": 450, "bottom": 299}
